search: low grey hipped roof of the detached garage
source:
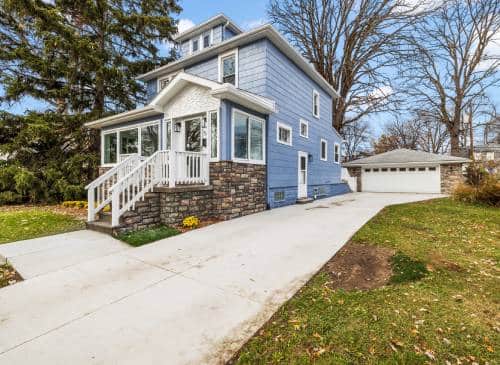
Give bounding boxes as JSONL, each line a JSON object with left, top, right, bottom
{"left": 343, "top": 148, "right": 470, "bottom": 166}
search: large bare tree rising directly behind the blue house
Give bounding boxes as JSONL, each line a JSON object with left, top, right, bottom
{"left": 268, "top": 0, "right": 417, "bottom": 134}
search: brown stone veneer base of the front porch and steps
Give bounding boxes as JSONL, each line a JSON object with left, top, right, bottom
{"left": 114, "top": 161, "right": 266, "bottom": 234}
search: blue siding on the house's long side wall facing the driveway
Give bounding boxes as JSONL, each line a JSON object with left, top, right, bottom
{"left": 265, "top": 41, "right": 345, "bottom": 208}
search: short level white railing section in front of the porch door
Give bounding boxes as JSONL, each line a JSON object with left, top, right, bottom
{"left": 174, "top": 152, "right": 209, "bottom": 186}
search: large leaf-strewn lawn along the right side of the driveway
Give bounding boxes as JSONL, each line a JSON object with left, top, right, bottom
{"left": 233, "top": 199, "right": 500, "bottom": 364}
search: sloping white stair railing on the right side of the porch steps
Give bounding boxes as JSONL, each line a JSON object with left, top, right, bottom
{"left": 110, "top": 151, "right": 170, "bottom": 227}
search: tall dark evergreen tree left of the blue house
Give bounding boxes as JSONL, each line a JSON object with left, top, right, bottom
{"left": 0, "top": 0, "right": 181, "bottom": 203}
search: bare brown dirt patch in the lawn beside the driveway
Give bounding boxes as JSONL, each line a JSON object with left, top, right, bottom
{"left": 324, "top": 242, "right": 395, "bottom": 290}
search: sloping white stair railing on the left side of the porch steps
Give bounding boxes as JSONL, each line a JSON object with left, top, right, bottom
{"left": 85, "top": 154, "right": 141, "bottom": 222}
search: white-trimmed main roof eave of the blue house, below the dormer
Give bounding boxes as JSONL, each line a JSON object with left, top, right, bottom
{"left": 136, "top": 24, "right": 338, "bottom": 97}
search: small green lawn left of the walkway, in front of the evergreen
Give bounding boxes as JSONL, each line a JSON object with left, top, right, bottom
{"left": 0, "top": 207, "right": 85, "bottom": 244}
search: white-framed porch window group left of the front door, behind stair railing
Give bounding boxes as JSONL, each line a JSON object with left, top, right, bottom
{"left": 101, "top": 120, "right": 160, "bottom": 166}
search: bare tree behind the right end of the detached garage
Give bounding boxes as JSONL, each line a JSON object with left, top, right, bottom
{"left": 401, "top": 0, "right": 500, "bottom": 155}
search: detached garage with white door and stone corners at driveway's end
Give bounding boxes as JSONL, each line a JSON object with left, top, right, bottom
{"left": 343, "top": 149, "right": 470, "bottom": 194}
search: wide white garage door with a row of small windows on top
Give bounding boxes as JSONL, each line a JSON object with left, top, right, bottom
{"left": 361, "top": 166, "right": 441, "bottom": 193}
